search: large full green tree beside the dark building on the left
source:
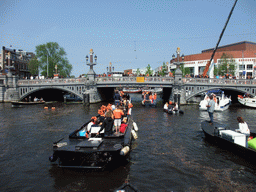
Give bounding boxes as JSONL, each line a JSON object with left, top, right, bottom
{"left": 36, "top": 42, "right": 72, "bottom": 77}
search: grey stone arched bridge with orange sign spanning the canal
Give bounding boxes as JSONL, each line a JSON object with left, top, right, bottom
{"left": 0, "top": 73, "right": 256, "bottom": 103}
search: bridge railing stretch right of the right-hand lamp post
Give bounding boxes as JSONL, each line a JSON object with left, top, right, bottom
{"left": 182, "top": 78, "right": 256, "bottom": 85}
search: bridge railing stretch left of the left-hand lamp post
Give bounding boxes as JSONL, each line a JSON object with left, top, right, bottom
{"left": 18, "top": 78, "right": 87, "bottom": 85}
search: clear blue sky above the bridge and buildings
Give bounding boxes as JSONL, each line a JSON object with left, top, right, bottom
{"left": 0, "top": 0, "right": 256, "bottom": 77}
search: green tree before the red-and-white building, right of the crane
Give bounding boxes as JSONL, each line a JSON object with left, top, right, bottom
{"left": 213, "top": 53, "right": 236, "bottom": 76}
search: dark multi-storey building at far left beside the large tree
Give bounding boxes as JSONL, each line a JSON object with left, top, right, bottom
{"left": 0, "top": 46, "right": 35, "bottom": 79}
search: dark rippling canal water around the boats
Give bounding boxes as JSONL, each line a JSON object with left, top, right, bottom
{"left": 0, "top": 94, "right": 256, "bottom": 192}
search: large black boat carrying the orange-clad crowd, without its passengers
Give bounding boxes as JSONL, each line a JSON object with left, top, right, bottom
{"left": 49, "top": 118, "right": 137, "bottom": 169}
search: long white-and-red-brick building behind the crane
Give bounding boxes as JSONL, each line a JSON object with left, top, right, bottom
{"left": 167, "top": 41, "right": 256, "bottom": 79}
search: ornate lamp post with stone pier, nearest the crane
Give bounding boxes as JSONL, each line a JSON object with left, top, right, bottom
{"left": 172, "top": 47, "right": 186, "bottom": 106}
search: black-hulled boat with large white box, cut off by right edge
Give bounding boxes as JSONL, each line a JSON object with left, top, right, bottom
{"left": 201, "top": 121, "right": 256, "bottom": 162}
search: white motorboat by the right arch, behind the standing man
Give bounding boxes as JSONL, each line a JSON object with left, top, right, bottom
{"left": 199, "top": 89, "right": 231, "bottom": 111}
